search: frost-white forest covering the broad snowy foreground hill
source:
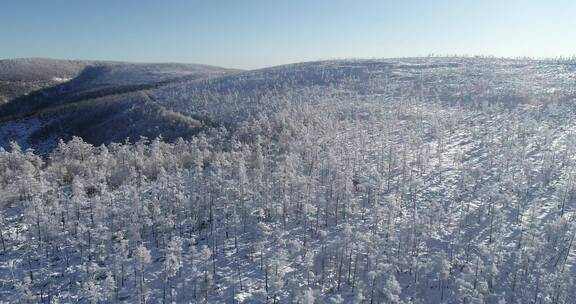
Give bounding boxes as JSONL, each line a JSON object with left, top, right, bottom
{"left": 0, "top": 58, "right": 576, "bottom": 304}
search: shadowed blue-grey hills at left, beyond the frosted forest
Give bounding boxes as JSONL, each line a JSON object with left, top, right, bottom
{"left": 0, "top": 59, "right": 238, "bottom": 153}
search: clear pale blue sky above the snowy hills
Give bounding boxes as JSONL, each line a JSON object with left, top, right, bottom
{"left": 0, "top": 0, "right": 576, "bottom": 68}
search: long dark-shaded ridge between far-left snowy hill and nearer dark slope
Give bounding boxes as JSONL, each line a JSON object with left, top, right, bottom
{"left": 0, "top": 61, "right": 235, "bottom": 117}
